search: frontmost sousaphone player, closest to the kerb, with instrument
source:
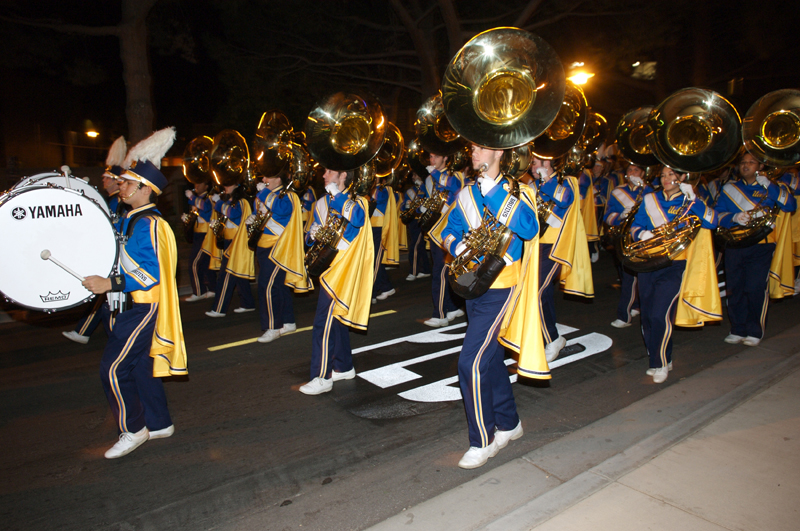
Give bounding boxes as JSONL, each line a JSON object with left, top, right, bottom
{"left": 431, "top": 28, "right": 565, "bottom": 468}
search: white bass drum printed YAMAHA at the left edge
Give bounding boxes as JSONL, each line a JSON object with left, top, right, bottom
{"left": 0, "top": 186, "right": 119, "bottom": 312}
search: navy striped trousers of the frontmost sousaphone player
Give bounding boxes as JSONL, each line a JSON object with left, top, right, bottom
{"left": 458, "top": 288, "right": 519, "bottom": 448}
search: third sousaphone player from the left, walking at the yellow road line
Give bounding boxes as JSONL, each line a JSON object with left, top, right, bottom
{"left": 245, "top": 110, "right": 313, "bottom": 343}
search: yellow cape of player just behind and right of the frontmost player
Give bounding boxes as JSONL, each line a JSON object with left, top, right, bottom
{"left": 550, "top": 177, "right": 594, "bottom": 298}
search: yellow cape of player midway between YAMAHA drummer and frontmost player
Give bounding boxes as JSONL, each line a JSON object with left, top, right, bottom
{"left": 319, "top": 197, "right": 375, "bottom": 330}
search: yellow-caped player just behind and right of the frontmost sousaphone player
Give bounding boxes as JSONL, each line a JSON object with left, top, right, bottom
{"left": 531, "top": 157, "right": 594, "bottom": 362}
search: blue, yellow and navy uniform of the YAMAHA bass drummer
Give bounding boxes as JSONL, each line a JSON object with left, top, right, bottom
{"left": 100, "top": 204, "right": 187, "bottom": 433}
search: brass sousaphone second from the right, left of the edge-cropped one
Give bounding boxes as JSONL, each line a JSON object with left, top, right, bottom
{"left": 618, "top": 88, "right": 741, "bottom": 272}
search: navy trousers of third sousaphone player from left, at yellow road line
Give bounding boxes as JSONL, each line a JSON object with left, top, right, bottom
{"left": 256, "top": 247, "right": 294, "bottom": 330}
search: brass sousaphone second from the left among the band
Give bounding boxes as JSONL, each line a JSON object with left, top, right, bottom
{"left": 209, "top": 129, "right": 250, "bottom": 249}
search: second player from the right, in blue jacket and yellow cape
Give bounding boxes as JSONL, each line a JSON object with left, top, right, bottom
{"left": 631, "top": 166, "right": 722, "bottom": 383}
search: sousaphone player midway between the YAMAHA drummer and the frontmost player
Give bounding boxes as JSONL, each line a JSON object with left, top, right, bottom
{"left": 299, "top": 92, "right": 387, "bottom": 395}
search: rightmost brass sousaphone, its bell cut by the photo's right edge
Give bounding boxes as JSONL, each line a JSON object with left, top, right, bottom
{"left": 716, "top": 89, "right": 800, "bottom": 249}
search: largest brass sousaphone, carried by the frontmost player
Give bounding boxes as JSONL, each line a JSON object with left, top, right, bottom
{"left": 440, "top": 28, "right": 566, "bottom": 299}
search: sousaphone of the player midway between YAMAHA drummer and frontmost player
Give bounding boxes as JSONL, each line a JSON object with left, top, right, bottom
{"left": 304, "top": 92, "right": 387, "bottom": 276}
